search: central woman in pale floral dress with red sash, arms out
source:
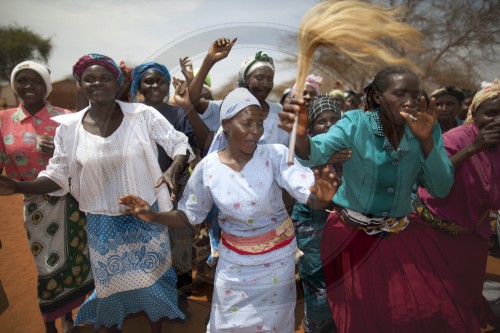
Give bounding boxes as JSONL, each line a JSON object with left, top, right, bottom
{"left": 120, "top": 88, "right": 336, "bottom": 332}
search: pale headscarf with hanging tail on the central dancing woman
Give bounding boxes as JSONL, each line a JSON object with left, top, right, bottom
{"left": 208, "top": 88, "right": 261, "bottom": 153}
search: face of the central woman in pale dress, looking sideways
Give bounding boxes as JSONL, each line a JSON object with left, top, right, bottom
{"left": 222, "top": 105, "right": 264, "bottom": 155}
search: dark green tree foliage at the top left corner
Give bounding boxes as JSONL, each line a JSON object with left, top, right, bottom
{"left": 0, "top": 25, "right": 52, "bottom": 82}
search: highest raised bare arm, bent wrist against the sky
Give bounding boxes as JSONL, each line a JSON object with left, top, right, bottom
{"left": 189, "top": 38, "right": 236, "bottom": 113}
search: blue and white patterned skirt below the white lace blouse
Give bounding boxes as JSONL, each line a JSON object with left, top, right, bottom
{"left": 75, "top": 204, "right": 184, "bottom": 328}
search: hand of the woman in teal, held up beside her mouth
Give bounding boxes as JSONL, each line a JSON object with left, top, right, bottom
{"left": 400, "top": 96, "right": 442, "bottom": 141}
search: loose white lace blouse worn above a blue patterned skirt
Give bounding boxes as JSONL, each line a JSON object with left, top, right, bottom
{"left": 39, "top": 101, "right": 193, "bottom": 215}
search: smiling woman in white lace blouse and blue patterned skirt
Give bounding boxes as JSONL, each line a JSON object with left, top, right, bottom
{"left": 0, "top": 54, "right": 193, "bottom": 332}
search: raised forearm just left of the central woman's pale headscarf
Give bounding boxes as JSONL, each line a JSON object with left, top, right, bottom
{"left": 172, "top": 77, "right": 214, "bottom": 150}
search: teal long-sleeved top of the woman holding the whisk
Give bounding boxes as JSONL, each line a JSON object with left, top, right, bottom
{"left": 299, "top": 110, "right": 453, "bottom": 217}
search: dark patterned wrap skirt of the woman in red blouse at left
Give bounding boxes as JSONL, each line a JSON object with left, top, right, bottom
{"left": 24, "top": 194, "right": 94, "bottom": 322}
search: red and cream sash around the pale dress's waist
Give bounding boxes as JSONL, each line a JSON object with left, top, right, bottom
{"left": 221, "top": 218, "right": 295, "bottom": 254}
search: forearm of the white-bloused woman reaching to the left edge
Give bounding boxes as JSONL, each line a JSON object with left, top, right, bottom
{"left": 0, "top": 175, "right": 61, "bottom": 195}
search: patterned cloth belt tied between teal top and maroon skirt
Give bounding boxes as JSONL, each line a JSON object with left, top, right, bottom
{"left": 337, "top": 208, "right": 409, "bottom": 235}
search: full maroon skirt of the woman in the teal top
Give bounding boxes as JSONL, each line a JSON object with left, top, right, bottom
{"left": 321, "top": 212, "right": 493, "bottom": 333}
